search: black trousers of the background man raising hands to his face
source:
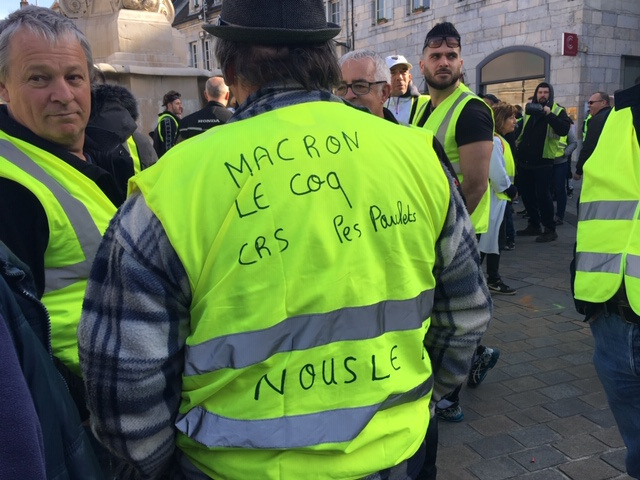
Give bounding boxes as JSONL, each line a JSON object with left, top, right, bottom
{"left": 519, "top": 164, "right": 556, "bottom": 231}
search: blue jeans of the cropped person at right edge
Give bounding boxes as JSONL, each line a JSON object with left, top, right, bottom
{"left": 590, "top": 312, "right": 640, "bottom": 478}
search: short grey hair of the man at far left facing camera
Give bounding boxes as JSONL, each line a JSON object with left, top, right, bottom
{"left": 0, "top": 5, "right": 94, "bottom": 81}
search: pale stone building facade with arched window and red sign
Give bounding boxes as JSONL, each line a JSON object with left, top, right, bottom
{"left": 174, "top": 0, "right": 640, "bottom": 127}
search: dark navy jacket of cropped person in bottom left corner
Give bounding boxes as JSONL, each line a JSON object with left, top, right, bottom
{"left": 0, "top": 242, "right": 103, "bottom": 480}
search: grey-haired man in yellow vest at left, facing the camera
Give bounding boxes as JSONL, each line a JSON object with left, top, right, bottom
{"left": 0, "top": 6, "right": 138, "bottom": 402}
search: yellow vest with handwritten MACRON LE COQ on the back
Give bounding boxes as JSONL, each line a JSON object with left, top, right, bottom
{"left": 131, "top": 102, "right": 451, "bottom": 480}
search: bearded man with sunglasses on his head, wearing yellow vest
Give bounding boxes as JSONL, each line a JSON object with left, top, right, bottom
{"left": 412, "top": 22, "right": 494, "bottom": 238}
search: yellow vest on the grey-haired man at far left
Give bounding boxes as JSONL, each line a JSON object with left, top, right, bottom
{"left": 0, "top": 131, "right": 116, "bottom": 375}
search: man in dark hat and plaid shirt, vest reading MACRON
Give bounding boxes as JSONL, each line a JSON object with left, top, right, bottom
{"left": 79, "top": 0, "right": 490, "bottom": 480}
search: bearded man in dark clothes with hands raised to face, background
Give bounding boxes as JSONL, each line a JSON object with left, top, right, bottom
{"left": 516, "top": 82, "right": 571, "bottom": 243}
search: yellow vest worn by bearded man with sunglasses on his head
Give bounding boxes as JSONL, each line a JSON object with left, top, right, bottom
{"left": 412, "top": 83, "right": 493, "bottom": 233}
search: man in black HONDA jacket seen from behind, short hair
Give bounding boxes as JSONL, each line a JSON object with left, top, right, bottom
{"left": 179, "top": 76, "right": 233, "bottom": 141}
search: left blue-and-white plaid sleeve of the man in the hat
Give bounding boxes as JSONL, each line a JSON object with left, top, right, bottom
{"left": 78, "top": 195, "right": 191, "bottom": 478}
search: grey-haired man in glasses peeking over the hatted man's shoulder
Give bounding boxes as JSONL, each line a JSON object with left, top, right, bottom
{"left": 335, "top": 50, "right": 398, "bottom": 123}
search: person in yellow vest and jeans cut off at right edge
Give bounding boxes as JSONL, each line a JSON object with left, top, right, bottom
{"left": 573, "top": 80, "right": 640, "bottom": 478}
